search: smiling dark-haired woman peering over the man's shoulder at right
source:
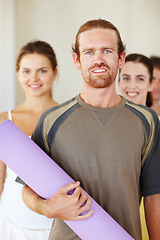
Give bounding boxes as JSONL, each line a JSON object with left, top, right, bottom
{"left": 118, "top": 53, "right": 153, "bottom": 240}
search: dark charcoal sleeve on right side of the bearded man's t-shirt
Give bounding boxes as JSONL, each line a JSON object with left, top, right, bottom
{"left": 140, "top": 117, "right": 160, "bottom": 197}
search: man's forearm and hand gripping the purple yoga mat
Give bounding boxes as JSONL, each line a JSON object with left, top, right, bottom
{"left": 22, "top": 182, "right": 93, "bottom": 220}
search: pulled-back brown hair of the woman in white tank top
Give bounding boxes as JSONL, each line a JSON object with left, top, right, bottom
{"left": 16, "top": 40, "right": 57, "bottom": 72}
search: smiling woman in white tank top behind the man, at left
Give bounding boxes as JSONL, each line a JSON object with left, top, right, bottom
{"left": 0, "top": 40, "right": 58, "bottom": 240}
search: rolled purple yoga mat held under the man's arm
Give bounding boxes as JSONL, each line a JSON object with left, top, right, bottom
{"left": 0, "top": 120, "right": 133, "bottom": 240}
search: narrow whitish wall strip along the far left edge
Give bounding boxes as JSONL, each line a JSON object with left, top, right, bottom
{"left": 0, "top": 0, "right": 16, "bottom": 111}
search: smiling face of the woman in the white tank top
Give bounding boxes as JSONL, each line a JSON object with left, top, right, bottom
{"left": 18, "top": 53, "right": 56, "bottom": 100}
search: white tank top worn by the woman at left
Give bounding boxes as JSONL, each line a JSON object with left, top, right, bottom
{"left": 0, "top": 111, "right": 53, "bottom": 229}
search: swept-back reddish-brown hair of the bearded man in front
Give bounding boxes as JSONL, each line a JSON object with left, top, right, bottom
{"left": 72, "top": 19, "right": 125, "bottom": 58}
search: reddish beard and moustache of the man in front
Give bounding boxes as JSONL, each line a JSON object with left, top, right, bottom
{"left": 82, "top": 63, "right": 117, "bottom": 88}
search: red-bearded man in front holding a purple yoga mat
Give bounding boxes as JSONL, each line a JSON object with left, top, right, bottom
{"left": 23, "top": 19, "right": 160, "bottom": 240}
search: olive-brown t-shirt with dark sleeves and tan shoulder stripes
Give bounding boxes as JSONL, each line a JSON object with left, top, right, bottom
{"left": 33, "top": 96, "right": 160, "bottom": 240}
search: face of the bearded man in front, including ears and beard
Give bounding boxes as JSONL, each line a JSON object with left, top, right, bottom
{"left": 74, "top": 28, "right": 124, "bottom": 88}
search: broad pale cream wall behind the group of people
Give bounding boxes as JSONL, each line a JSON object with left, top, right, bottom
{"left": 0, "top": 0, "right": 160, "bottom": 111}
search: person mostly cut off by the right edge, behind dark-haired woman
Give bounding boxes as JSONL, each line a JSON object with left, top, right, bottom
{"left": 150, "top": 56, "right": 160, "bottom": 117}
